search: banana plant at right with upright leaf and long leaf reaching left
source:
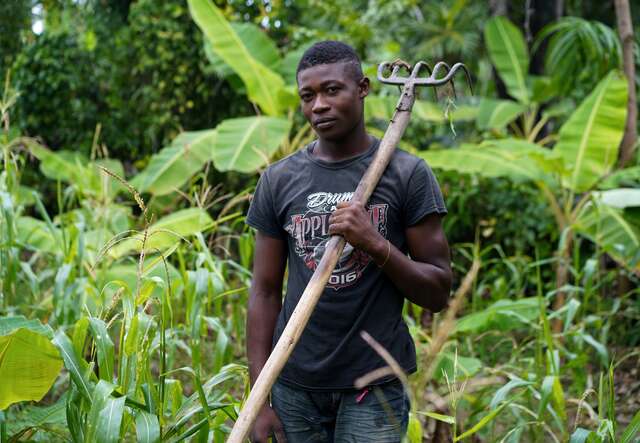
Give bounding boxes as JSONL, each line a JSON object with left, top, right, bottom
{"left": 421, "top": 71, "right": 640, "bottom": 308}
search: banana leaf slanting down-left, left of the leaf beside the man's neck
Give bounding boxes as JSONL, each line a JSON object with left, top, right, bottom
{"left": 131, "top": 129, "right": 216, "bottom": 195}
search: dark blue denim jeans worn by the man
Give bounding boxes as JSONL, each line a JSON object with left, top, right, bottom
{"left": 271, "top": 380, "right": 410, "bottom": 443}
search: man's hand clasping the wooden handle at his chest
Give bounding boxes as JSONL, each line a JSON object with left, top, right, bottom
{"left": 329, "top": 201, "right": 384, "bottom": 253}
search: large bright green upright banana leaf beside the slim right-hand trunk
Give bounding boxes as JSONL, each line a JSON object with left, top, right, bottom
{"left": 554, "top": 71, "right": 627, "bottom": 192}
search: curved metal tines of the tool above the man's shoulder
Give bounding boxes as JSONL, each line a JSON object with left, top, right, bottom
{"left": 378, "top": 60, "right": 473, "bottom": 94}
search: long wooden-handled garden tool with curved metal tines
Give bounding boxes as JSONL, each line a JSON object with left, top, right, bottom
{"left": 227, "top": 60, "right": 471, "bottom": 443}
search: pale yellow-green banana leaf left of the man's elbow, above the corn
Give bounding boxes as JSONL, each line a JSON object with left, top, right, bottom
{"left": 109, "top": 208, "right": 213, "bottom": 258}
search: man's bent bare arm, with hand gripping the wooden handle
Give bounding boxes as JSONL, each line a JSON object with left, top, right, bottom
{"left": 329, "top": 202, "right": 452, "bottom": 312}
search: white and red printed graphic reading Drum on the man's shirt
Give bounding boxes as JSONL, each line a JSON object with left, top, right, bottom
{"left": 284, "top": 192, "right": 389, "bottom": 290}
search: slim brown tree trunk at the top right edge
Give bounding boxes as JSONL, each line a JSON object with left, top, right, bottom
{"left": 615, "top": 0, "right": 638, "bottom": 167}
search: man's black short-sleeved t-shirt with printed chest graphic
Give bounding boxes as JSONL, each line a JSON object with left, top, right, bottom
{"left": 246, "top": 140, "right": 446, "bottom": 390}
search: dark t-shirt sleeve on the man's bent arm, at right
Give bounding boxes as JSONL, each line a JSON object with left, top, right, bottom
{"left": 404, "top": 160, "right": 447, "bottom": 226}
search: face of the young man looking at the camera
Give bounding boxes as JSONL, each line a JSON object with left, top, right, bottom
{"left": 298, "top": 63, "right": 369, "bottom": 140}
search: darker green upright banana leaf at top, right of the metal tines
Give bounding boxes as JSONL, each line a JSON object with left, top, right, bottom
{"left": 484, "top": 17, "right": 530, "bottom": 104}
